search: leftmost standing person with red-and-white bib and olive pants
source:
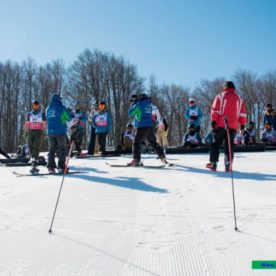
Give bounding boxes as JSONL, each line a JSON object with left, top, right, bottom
{"left": 25, "top": 101, "right": 46, "bottom": 173}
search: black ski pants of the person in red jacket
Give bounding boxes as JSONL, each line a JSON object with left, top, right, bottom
{"left": 210, "top": 127, "right": 237, "bottom": 163}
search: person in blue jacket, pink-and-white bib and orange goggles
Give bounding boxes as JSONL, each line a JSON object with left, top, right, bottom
{"left": 92, "top": 101, "right": 112, "bottom": 155}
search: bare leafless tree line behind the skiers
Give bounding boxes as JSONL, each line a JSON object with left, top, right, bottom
{"left": 0, "top": 49, "right": 276, "bottom": 152}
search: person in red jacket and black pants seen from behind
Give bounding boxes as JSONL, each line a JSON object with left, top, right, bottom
{"left": 206, "top": 81, "right": 246, "bottom": 172}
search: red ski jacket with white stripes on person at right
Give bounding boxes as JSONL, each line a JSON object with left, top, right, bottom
{"left": 211, "top": 88, "right": 246, "bottom": 129}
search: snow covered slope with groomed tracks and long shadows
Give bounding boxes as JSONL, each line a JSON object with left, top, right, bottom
{"left": 0, "top": 152, "right": 276, "bottom": 276}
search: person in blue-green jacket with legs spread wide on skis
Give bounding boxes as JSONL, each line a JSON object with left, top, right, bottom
{"left": 128, "top": 94, "right": 167, "bottom": 166}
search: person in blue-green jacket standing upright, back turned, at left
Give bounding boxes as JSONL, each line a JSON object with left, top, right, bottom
{"left": 46, "top": 94, "right": 70, "bottom": 173}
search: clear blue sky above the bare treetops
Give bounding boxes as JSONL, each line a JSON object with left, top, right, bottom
{"left": 0, "top": 0, "right": 276, "bottom": 87}
